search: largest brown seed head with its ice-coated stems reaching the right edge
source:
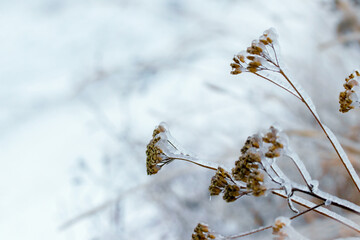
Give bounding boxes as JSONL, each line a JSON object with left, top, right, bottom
{"left": 209, "top": 127, "right": 360, "bottom": 214}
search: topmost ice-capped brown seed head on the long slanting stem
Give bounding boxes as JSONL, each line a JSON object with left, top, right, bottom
{"left": 230, "top": 29, "right": 279, "bottom": 75}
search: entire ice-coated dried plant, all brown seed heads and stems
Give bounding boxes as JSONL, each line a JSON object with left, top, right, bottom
{"left": 146, "top": 29, "right": 360, "bottom": 239}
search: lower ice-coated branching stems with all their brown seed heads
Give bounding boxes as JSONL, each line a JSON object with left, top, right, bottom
{"left": 146, "top": 123, "right": 360, "bottom": 240}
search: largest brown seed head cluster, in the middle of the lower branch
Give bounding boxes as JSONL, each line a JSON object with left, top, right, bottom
{"left": 209, "top": 127, "right": 284, "bottom": 202}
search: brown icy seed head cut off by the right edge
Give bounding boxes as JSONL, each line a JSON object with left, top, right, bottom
{"left": 339, "top": 71, "right": 360, "bottom": 113}
